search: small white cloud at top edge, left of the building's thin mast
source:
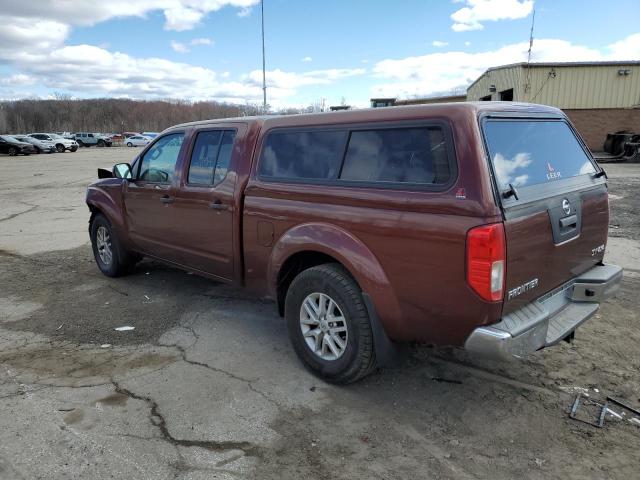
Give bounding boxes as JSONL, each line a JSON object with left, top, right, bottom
{"left": 451, "top": 0, "right": 533, "bottom": 32}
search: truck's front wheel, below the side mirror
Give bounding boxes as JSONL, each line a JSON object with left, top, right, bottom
{"left": 90, "top": 213, "right": 136, "bottom": 277}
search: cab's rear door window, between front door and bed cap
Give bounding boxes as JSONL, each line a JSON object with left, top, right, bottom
{"left": 188, "top": 130, "right": 235, "bottom": 185}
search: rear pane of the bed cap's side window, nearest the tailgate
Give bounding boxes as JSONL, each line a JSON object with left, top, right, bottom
{"left": 340, "top": 127, "right": 451, "bottom": 184}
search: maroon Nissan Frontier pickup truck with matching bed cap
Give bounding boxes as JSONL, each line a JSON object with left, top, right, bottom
{"left": 86, "top": 102, "right": 622, "bottom": 383}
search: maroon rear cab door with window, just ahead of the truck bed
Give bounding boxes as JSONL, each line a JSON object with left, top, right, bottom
{"left": 172, "top": 126, "right": 244, "bottom": 280}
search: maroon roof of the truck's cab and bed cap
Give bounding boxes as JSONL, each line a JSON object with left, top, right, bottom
{"left": 168, "top": 101, "right": 562, "bottom": 130}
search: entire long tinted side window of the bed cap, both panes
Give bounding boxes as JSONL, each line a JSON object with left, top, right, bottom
{"left": 258, "top": 126, "right": 452, "bottom": 185}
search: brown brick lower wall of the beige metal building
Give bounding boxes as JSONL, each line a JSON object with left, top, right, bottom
{"left": 564, "top": 108, "right": 640, "bottom": 151}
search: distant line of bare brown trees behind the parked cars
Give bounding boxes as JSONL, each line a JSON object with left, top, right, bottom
{"left": 0, "top": 96, "right": 314, "bottom": 134}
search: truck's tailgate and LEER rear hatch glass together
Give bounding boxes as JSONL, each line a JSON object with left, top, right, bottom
{"left": 481, "top": 115, "right": 609, "bottom": 314}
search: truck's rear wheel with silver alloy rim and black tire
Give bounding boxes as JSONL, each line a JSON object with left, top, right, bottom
{"left": 285, "top": 263, "right": 376, "bottom": 384}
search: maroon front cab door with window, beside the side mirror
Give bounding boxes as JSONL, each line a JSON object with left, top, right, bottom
{"left": 123, "top": 132, "right": 184, "bottom": 261}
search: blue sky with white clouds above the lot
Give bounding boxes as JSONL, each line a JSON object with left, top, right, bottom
{"left": 0, "top": 0, "right": 640, "bottom": 109}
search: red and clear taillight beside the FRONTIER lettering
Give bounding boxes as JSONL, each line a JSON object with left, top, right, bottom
{"left": 467, "top": 223, "right": 506, "bottom": 302}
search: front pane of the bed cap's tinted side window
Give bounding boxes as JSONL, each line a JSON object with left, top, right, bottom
{"left": 259, "top": 130, "right": 347, "bottom": 180}
